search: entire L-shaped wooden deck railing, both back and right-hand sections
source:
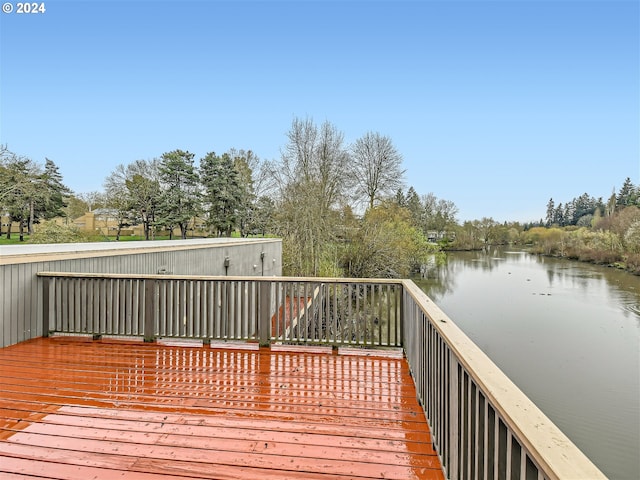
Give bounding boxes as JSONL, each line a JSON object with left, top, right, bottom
{"left": 38, "top": 273, "right": 605, "bottom": 480}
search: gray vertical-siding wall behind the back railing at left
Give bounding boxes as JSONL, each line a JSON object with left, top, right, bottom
{"left": 0, "top": 239, "right": 282, "bottom": 347}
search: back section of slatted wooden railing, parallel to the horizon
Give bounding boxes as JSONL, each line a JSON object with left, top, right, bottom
{"left": 38, "top": 272, "right": 402, "bottom": 347}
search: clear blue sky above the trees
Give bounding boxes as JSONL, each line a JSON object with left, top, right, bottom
{"left": 0, "top": 0, "right": 640, "bottom": 221}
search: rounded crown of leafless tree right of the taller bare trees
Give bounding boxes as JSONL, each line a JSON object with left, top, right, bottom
{"left": 351, "top": 132, "right": 405, "bottom": 208}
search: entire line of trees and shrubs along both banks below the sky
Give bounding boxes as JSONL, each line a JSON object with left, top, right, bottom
{"left": 0, "top": 118, "right": 640, "bottom": 278}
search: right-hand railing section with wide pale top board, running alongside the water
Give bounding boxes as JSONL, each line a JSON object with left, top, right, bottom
{"left": 403, "top": 281, "right": 606, "bottom": 480}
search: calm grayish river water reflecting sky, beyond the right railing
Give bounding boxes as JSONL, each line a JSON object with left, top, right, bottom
{"left": 414, "top": 249, "right": 640, "bottom": 480}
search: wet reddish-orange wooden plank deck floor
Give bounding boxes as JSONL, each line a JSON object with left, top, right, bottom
{"left": 0, "top": 338, "right": 444, "bottom": 480}
